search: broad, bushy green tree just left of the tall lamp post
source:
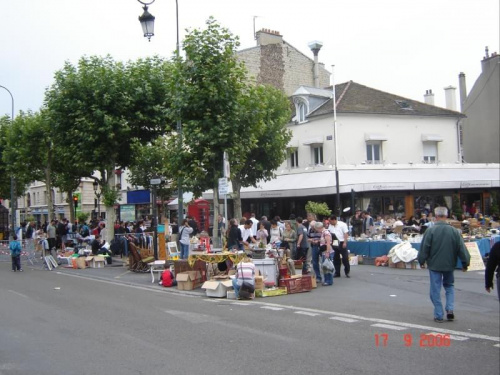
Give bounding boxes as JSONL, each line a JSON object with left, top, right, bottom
{"left": 45, "top": 56, "right": 171, "bottom": 241}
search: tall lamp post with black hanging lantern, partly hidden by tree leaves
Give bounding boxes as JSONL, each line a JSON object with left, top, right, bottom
{"left": 137, "top": 0, "right": 184, "bottom": 223}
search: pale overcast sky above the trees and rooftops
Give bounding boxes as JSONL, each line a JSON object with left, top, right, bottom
{"left": 0, "top": 0, "right": 499, "bottom": 116}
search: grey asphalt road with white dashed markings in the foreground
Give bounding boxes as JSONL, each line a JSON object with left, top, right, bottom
{"left": 0, "top": 262, "right": 500, "bottom": 375}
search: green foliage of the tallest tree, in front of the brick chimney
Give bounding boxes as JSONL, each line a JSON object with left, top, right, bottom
{"left": 163, "top": 18, "right": 247, "bottom": 196}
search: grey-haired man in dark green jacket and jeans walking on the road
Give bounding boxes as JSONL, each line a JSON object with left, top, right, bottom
{"left": 418, "top": 207, "right": 470, "bottom": 323}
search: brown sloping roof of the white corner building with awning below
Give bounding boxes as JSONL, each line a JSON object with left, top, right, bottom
{"left": 308, "top": 81, "right": 465, "bottom": 117}
